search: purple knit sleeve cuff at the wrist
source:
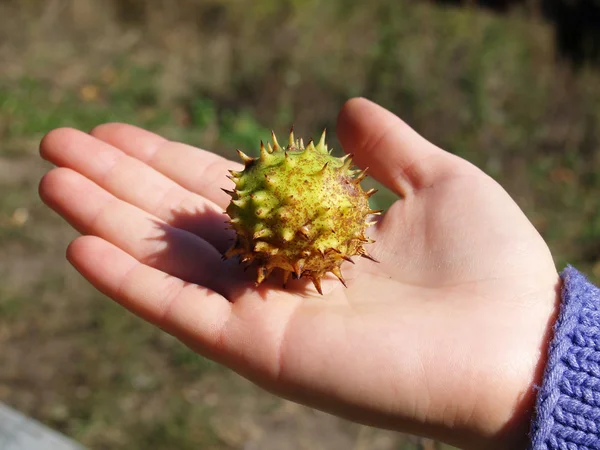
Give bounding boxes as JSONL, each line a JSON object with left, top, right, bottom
{"left": 530, "top": 266, "right": 600, "bottom": 450}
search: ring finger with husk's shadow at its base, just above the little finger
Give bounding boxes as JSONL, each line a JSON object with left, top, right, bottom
{"left": 40, "top": 168, "right": 231, "bottom": 292}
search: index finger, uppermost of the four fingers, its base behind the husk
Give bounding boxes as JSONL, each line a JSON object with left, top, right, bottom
{"left": 91, "top": 123, "right": 243, "bottom": 209}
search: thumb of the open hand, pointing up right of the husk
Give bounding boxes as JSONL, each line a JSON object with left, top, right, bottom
{"left": 337, "top": 98, "right": 458, "bottom": 196}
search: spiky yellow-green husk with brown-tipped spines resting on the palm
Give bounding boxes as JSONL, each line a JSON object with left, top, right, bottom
{"left": 224, "top": 131, "right": 381, "bottom": 293}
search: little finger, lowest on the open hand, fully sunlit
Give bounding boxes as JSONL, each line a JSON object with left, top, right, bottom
{"left": 67, "top": 236, "right": 231, "bottom": 348}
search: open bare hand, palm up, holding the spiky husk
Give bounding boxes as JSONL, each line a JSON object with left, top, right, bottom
{"left": 40, "top": 99, "right": 559, "bottom": 449}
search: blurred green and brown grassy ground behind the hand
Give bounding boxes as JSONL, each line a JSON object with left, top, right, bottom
{"left": 0, "top": 0, "right": 600, "bottom": 450}
